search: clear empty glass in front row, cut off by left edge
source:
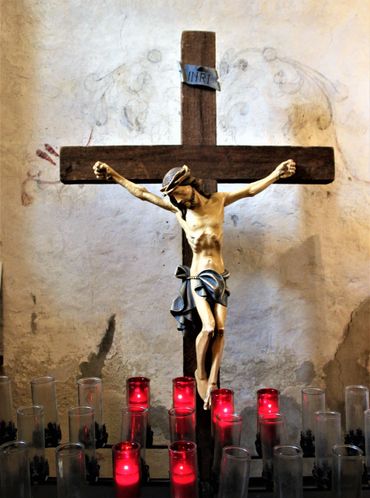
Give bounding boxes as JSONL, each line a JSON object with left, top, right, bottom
{"left": 0, "top": 441, "right": 32, "bottom": 498}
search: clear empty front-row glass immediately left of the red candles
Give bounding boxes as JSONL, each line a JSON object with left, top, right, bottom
{"left": 55, "top": 443, "right": 86, "bottom": 498}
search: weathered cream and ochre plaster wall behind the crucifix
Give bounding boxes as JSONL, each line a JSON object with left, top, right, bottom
{"left": 0, "top": 0, "right": 370, "bottom": 447}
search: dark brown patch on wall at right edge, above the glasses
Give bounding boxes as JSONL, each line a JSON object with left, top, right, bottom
{"left": 324, "top": 297, "right": 370, "bottom": 413}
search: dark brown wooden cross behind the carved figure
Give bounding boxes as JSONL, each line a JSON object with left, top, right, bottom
{"left": 60, "top": 31, "right": 334, "bottom": 481}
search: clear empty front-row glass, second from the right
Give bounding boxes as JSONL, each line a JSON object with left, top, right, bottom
{"left": 273, "top": 445, "right": 303, "bottom": 498}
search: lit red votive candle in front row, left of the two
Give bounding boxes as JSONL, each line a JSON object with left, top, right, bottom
{"left": 112, "top": 441, "right": 140, "bottom": 498}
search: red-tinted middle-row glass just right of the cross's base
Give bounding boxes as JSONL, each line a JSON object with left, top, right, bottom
{"left": 212, "top": 413, "right": 243, "bottom": 475}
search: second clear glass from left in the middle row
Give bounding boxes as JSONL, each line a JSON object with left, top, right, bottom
{"left": 68, "top": 406, "right": 95, "bottom": 459}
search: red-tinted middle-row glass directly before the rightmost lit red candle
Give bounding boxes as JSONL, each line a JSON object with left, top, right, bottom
{"left": 260, "top": 413, "right": 284, "bottom": 482}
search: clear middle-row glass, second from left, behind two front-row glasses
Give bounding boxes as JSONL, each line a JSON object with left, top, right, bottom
{"left": 68, "top": 406, "right": 100, "bottom": 483}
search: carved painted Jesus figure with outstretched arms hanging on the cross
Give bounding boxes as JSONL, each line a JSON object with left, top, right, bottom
{"left": 93, "top": 159, "right": 296, "bottom": 410}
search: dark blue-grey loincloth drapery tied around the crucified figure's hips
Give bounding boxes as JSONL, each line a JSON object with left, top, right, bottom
{"left": 170, "top": 265, "right": 230, "bottom": 332}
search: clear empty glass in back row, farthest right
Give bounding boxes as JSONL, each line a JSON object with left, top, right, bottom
{"left": 344, "top": 386, "right": 369, "bottom": 451}
